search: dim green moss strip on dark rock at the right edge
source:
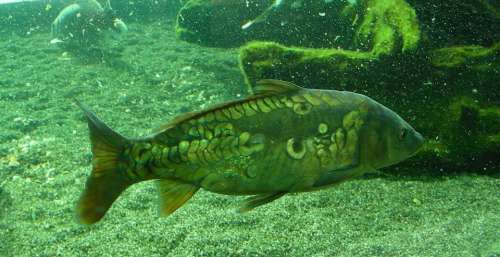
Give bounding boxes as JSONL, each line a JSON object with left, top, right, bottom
{"left": 431, "top": 43, "right": 500, "bottom": 70}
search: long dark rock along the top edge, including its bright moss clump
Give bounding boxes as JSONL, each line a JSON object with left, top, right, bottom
{"left": 176, "top": 0, "right": 500, "bottom": 56}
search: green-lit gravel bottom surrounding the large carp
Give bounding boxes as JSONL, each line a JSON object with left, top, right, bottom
{"left": 0, "top": 1, "right": 500, "bottom": 257}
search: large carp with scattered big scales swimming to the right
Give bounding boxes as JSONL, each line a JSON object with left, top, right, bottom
{"left": 76, "top": 79, "right": 424, "bottom": 224}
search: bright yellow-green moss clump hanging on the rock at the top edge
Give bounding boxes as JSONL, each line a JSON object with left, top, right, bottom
{"left": 356, "top": 0, "right": 420, "bottom": 56}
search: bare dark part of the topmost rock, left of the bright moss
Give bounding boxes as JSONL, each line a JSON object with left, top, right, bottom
{"left": 176, "top": 0, "right": 353, "bottom": 47}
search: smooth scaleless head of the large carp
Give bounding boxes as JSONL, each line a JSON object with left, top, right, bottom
{"left": 361, "top": 99, "right": 425, "bottom": 169}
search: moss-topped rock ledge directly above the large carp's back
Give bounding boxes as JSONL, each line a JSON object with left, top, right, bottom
{"left": 239, "top": 41, "right": 379, "bottom": 90}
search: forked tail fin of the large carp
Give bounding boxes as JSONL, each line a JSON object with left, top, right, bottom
{"left": 76, "top": 101, "right": 133, "bottom": 224}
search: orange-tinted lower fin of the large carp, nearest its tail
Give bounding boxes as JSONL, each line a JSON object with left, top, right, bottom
{"left": 158, "top": 179, "right": 199, "bottom": 216}
